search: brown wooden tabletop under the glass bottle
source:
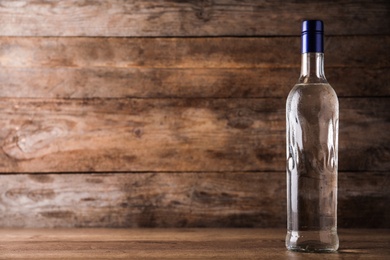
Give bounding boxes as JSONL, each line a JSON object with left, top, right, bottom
{"left": 0, "top": 229, "right": 390, "bottom": 259}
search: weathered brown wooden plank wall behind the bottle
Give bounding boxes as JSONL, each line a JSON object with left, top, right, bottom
{"left": 0, "top": 0, "right": 390, "bottom": 228}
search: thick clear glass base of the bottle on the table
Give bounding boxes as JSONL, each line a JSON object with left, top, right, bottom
{"left": 286, "top": 231, "right": 339, "bottom": 253}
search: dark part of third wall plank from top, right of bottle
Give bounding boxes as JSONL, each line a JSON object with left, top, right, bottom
{"left": 339, "top": 98, "right": 390, "bottom": 171}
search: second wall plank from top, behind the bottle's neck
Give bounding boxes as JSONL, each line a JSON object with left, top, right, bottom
{"left": 0, "top": 36, "right": 390, "bottom": 98}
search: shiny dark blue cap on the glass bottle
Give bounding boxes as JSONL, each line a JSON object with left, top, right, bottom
{"left": 302, "top": 20, "right": 324, "bottom": 53}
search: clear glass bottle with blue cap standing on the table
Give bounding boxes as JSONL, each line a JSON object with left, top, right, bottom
{"left": 286, "top": 20, "right": 339, "bottom": 252}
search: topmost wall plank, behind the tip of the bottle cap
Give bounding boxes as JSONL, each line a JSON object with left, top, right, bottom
{"left": 0, "top": 0, "right": 390, "bottom": 37}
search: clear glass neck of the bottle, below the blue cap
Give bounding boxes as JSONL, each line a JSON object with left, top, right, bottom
{"left": 298, "top": 52, "right": 327, "bottom": 83}
